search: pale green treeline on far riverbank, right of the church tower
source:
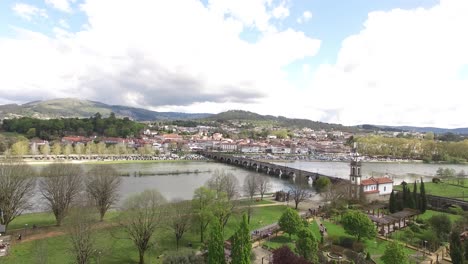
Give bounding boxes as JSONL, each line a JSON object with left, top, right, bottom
{"left": 356, "top": 136, "right": 468, "bottom": 163}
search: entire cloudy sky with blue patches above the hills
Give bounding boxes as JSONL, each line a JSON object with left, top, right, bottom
{"left": 0, "top": 0, "right": 468, "bottom": 128}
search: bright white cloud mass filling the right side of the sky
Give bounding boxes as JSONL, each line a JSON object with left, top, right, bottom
{"left": 310, "top": 0, "right": 468, "bottom": 127}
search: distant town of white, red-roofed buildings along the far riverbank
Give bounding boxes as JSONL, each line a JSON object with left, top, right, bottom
{"left": 22, "top": 121, "right": 423, "bottom": 161}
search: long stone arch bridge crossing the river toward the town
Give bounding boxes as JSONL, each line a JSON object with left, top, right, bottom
{"left": 199, "top": 151, "right": 347, "bottom": 184}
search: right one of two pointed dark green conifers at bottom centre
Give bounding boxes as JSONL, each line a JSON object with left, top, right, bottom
{"left": 231, "top": 214, "right": 252, "bottom": 264}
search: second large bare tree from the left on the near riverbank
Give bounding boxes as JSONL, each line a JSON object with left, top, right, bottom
{"left": 39, "top": 163, "right": 83, "bottom": 226}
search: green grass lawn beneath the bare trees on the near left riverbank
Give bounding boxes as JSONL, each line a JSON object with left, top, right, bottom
{"left": 1, "top": 206, "right": 286, "bottom": 264}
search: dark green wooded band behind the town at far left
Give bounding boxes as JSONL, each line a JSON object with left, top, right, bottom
{"left": 2, "top": 113, "right": 144, "bottom": 140}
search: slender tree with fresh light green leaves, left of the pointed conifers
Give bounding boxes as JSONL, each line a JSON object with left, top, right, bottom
{"left": 192, "top": 187, "right": 216, "bottom": 242}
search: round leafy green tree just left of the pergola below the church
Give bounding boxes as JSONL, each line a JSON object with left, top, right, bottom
{"left": 341, "top": 210, "right": 377, "bottom": 241}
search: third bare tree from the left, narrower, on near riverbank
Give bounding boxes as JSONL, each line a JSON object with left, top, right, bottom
{"left": 85, "top": 165, "right": 122, "bottom": 221}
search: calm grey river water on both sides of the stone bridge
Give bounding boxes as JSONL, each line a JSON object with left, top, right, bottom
{"left": 29, "top": 161, "right": 468, "bottom": 211}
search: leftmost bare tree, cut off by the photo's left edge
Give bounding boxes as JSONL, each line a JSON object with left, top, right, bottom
{"left": 0, "top": 159, "right": 36, "bottom": 230}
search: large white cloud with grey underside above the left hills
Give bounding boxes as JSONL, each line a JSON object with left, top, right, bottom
{"left": 0, "top": 0, "right": 320, "bottom": 113}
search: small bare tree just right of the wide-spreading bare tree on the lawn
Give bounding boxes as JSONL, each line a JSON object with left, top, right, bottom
{"left": 167, "top": 200, "right": 193, "bottom": 250}
